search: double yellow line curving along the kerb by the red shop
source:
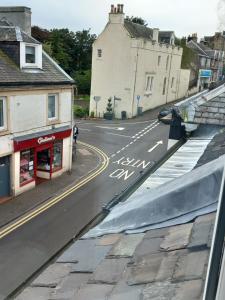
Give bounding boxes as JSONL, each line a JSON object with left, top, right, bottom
{"left": 0, "top": 142, "right": 109, "bottom": 239}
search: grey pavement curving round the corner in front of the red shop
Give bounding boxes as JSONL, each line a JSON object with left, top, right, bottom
{"left": 0, "top": 144, "right": 100, "bottom": 227}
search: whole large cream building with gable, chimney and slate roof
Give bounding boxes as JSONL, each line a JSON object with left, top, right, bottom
{"left": 90, "top": 5, "right": 190, "bottom": 119}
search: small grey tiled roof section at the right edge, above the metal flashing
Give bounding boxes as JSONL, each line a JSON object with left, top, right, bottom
{"left": 194, "top": 93, "right": 225, "bottom": 126}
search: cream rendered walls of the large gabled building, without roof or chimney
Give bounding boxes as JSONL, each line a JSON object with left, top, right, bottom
{"left": 90, "top": 19, "right": 189, "bottom": 118}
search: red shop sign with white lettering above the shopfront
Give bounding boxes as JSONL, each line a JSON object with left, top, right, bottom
{"left": 13, "top": 129, "right": 71, "bottom": 152}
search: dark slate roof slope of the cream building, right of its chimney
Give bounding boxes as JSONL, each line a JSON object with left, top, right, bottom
{"left": 124, "top": 20, "right": 153, "bottom": 40}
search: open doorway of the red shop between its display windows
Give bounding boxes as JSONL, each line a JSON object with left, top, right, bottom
{"left": 36, "top": 146, "right": 52, "bottom": 184}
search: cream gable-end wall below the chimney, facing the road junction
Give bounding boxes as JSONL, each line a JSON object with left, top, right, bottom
{"left": 90, "top": 24, "right": 135, "bottom": 117}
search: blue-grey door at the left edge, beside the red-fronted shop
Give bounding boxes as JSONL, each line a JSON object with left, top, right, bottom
{"left": 0, "top": 156, "right": 10, "bottom": 200}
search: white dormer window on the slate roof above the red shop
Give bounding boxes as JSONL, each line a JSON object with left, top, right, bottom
{"left": 20, "top": 42, "right": 42, "bottom": 72}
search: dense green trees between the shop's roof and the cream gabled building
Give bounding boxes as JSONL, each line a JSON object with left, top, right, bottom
{"left": 32, "top": 26, "right": 96, "bottom": 94}
